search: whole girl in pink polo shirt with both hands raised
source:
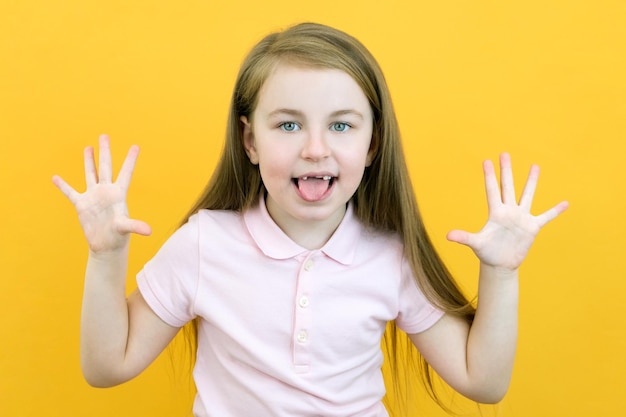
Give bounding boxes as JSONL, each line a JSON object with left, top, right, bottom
{"left": 53, "top": 24, "right": 567, "bottom": 417}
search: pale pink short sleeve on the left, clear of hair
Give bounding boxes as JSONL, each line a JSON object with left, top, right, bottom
{"left": 137, "top": 215, "right": 199, "bottom": 327}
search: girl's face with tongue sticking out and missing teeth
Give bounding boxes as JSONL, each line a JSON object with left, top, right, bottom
{"left": 241, "top": 64, "right": 373, "bottom": 244}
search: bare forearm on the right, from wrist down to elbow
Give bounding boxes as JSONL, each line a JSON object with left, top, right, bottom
{"left": 467, "top": 264, "right": 519, "bottom": 402}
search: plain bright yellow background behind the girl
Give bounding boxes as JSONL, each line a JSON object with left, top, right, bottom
{"left": 0, "top": 0, "right": 626, "bottom": 417}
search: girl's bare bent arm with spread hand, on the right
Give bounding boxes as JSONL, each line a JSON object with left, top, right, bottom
{"left": 409, "top": 154, "right": 568, "bottom": 403}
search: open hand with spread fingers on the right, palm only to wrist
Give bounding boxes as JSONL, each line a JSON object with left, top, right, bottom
{"left": 447, "top": 153, "right": 568, "bottom": 271}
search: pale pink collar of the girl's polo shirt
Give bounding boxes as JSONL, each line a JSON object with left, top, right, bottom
{"left": 243, "top": 195, "right": 362, "bottom": 265}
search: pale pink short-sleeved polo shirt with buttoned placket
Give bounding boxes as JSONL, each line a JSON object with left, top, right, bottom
{"left": 137, "top": 197, "right": 443, "bottom": 417}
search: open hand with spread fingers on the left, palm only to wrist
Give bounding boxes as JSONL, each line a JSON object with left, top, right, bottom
{"left": 52, "top": 135, "right": 151, "bottom": 255}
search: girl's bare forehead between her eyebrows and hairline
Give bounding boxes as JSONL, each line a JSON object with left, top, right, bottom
{"left": 255, "top": 63, "right": 370, "bottom": 113}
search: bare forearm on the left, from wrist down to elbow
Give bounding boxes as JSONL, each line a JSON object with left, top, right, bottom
{"left": 80, "top": 250, "right": 129, "bottom": 386}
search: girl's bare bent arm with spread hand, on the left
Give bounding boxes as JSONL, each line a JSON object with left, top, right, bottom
{"left": 53, "top": 136, "right": 178, "bottom": 387}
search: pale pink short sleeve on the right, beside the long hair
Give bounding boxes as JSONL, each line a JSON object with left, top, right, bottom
{"left": 396, "top": 258, "right": 444, "bottom": 334}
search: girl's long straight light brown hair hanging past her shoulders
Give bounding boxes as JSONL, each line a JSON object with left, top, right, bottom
{"left": 176, "top": 23, "right": 475, "bottom": 412}
